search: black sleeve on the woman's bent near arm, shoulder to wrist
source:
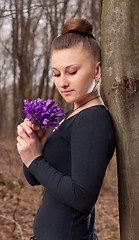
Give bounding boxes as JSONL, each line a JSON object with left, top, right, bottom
{"left": 29, "top": 111, "right": 112, "bottom": 212}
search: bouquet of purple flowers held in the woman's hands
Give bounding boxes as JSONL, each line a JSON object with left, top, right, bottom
{"left": 22, "top": 98, "right": 65, "bottom": 130}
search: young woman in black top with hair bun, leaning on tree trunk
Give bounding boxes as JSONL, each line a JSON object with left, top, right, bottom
{"left": 17, "top": 19, "right": 115, "bottom": 240}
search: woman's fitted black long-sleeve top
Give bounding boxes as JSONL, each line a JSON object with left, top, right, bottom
{"left": 24, "top": 105, "right": 115, "bottom": 240}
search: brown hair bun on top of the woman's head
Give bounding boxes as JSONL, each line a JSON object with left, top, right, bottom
{"left": 62, "top": 18, "right": 93, "bottom": 35}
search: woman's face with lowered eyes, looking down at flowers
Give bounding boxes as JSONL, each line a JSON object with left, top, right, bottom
{"left": 51, "top": 44, "right": 99, "bottom": 107}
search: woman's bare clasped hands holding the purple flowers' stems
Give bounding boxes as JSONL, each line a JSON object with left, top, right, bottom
{"left": 17, "top": 120, "right": 48, "bottom": 167}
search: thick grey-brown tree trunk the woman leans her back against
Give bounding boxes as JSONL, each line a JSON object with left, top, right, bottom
{"left": 101, "top": 0, "right": 139, "bottom": 240}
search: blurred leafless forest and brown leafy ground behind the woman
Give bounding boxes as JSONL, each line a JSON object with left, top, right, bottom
{"left": 0, "top": 0, "right": 120, "bottom": 240}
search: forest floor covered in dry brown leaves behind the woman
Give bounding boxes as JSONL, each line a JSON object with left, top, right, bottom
{"left": 0, "top": 134, "right": 120, "bottom": 240}
